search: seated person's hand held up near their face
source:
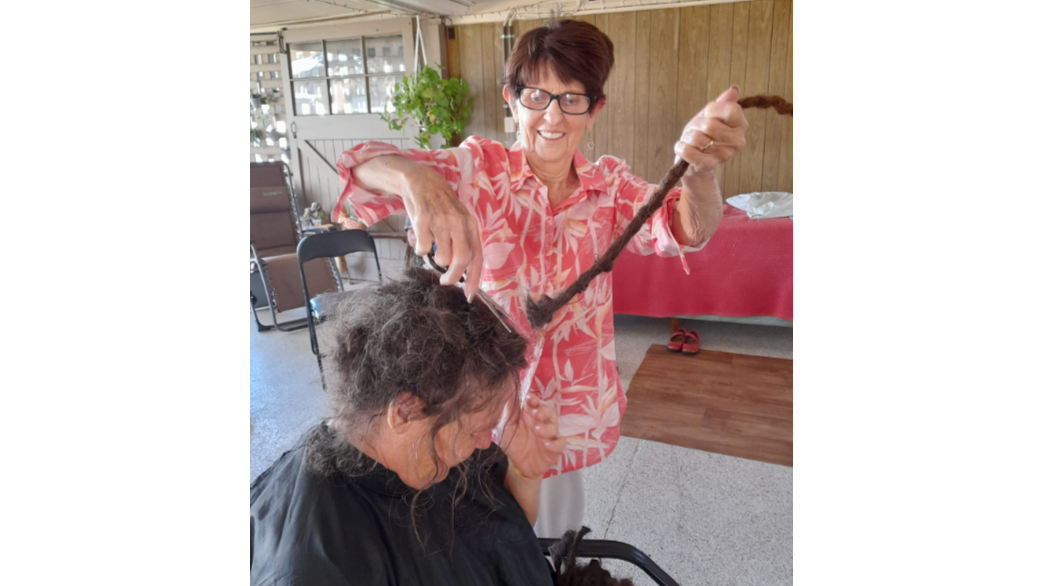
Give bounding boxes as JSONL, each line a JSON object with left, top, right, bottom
{"left": 499, "top": 395, "right": 566, "bottom": 480}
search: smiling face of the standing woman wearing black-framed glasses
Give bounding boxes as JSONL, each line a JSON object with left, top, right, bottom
{"left": 503, "top": 68, "right": 602, "bottom": 168}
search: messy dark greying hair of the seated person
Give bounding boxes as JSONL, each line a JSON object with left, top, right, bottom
{"left": 307, "top": 267, "right": 526, "bottom": 483}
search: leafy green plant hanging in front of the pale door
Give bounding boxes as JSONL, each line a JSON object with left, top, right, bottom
{"left": 380, "top": 66, "right": 474, "bottom": 149}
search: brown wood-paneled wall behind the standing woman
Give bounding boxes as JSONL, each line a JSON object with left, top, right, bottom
{"left": 448, "top": 0, "right": 794, "bottom": 197}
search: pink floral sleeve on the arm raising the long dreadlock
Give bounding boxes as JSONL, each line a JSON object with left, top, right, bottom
{"left": 597, "top": 156, "right": 709, "bottom": 274}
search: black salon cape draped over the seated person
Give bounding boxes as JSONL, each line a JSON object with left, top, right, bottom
{"left": 250, "top": 435, "right": 553, "bottom": 586}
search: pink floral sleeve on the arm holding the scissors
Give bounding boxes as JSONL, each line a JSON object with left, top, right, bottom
{"left": 332, "top": 137, "right": 508, "bottom": 225}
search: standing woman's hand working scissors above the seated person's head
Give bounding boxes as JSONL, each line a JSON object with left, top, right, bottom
{"left": 401, "top": 165, "right": 485, "bottom": 299}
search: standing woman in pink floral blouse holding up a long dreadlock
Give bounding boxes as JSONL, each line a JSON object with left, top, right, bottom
{"left": 334, "top": 20, "right": 748, "bottom": 537}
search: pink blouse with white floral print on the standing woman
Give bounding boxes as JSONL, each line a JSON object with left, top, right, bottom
{"left": 333, "top": 137, "right": 704, "bottom": 477}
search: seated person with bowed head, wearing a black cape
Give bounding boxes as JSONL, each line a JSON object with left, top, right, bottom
{"left": 250, "top": 268, "right": 564, "bottom": 586}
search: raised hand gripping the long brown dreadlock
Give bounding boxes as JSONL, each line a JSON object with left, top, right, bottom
{"left": 673, "top": 88, "right": 749, "bottom": 179}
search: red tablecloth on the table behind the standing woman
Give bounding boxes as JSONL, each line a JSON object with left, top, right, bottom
{"left": 613, "top": 204, "right": 795, "bottom": 321}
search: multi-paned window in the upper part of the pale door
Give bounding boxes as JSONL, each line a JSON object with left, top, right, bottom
{"left": 290, "top": 34, "right": 405, "bottom": 116}
